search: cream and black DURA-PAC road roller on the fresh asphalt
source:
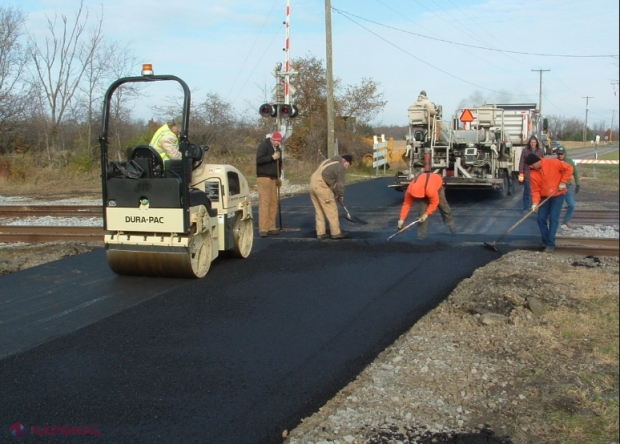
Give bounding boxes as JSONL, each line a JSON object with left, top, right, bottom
{"left": 99, "top": 65, "right": 254, "bottom": 278}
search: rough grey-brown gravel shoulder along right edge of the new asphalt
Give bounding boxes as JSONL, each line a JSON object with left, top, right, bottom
{"left": 284, "top": 251, "right": 618, "bottom": 444}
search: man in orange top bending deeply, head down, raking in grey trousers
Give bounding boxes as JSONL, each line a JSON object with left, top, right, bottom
{"left": 398, "top": 173, "right": 456, "bottom": 240}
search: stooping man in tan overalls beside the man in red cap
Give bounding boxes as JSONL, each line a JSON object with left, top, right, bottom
{"left": 310, "top": 154, "right": 353, "bottom": 239}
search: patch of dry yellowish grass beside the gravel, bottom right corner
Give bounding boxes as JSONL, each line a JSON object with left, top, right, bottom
{"left": 546, "top": 282, "right": 619, "bottom": 444}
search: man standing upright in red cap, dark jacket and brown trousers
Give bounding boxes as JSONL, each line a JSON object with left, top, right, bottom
{"left": 256, "top": 131, "right": 282, "bottom": 237}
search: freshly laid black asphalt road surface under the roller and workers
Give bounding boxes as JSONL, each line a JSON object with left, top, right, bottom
{"left": 0, "top": 178, "right": 539, "bottom": 444}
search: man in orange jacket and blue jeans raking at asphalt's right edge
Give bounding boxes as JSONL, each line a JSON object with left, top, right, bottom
{"left": 525, "top": 154, "right": 573, "bottom": 253}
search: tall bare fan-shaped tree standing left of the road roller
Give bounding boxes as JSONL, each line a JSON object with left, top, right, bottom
{"left": 30, "top": 1, "right": 103, "bottom": 162}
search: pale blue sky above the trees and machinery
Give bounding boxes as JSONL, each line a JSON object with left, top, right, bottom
{"left": 15, "top": 0, "right": 620, "bottom": 126}
